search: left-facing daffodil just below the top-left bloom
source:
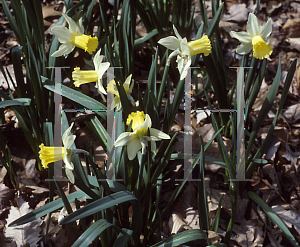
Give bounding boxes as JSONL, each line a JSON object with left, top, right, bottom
{"left": 72, "top": 49, "right": 110, "bottom": 94}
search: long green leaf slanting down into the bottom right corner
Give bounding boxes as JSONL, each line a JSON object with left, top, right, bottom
{"left": 248, "top": 191, "right": 299, "bottom": 247}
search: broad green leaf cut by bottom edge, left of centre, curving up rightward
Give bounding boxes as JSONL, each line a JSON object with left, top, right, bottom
{"left": 72, "top": 219, "right": 113, "bottom": 247}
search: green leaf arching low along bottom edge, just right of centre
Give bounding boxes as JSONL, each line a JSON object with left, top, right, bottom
{"left": 151, "top": 229, "right": 207, "bottom": 247}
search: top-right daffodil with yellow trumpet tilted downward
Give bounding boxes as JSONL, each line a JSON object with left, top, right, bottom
{"left": 231, "top": 13, "right": 273, "bottom": 60}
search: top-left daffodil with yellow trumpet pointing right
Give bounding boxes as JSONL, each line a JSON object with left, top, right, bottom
{"left": 51, "top": 14, "right": 98, "bottom": 57}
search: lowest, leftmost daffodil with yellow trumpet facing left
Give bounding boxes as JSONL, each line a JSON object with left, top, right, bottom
{"left": 39, "top": 123, "right": 76, "bottom": 170}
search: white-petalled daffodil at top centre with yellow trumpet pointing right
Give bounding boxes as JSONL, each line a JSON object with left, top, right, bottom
{"left": 158, "top": 25, "right": 211, "bottom": 80}
